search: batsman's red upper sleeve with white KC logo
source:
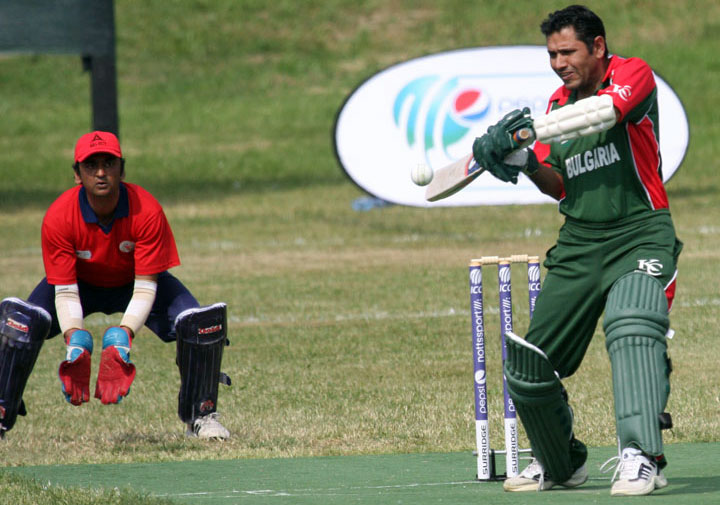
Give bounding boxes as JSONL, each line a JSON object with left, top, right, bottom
{"left": 598, "top": 56, "right": 655, "bottom": 121}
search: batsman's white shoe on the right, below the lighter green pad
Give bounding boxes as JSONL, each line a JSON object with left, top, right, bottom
{"left": 610, "top": 447, "right": 667, "bottom": 496}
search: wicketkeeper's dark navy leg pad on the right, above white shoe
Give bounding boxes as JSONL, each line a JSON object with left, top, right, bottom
{"left": 175, "top": 303, "right": 229, "bottom": 423}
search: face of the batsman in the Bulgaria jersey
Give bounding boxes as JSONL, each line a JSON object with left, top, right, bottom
{"left": 547, "top": 26, "right": 605, "bottom": 98}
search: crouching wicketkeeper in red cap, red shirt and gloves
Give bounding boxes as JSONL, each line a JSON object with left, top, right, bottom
{"left": 0, "top": 131, "right": 230, "bottom": 439}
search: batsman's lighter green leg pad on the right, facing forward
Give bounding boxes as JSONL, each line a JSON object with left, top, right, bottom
{"left": 603, "top": 272, "right": 671, "bottom": 456}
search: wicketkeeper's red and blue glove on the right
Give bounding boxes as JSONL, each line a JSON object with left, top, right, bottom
{"left": 95, "top": 326, "right": 135, "bottom": 405}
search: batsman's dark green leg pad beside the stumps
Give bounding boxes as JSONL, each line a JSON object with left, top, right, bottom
{"left": 505, "top": 332, "right": 587, "bottom": 483}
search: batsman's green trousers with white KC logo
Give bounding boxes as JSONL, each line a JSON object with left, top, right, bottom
{"left": 525, "top": 210, "right": 682, "bottom": 378}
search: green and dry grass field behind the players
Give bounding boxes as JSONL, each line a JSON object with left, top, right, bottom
{"left": 0, "top": 0, "right": 720, "bottom": 503}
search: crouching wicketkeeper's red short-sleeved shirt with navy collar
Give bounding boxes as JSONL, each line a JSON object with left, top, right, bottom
{"left": 42, "top": 183, "right": 180, "bottom": 287}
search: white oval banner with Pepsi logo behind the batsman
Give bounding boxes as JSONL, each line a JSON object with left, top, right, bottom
{"left": 335, "top": 46, "right": 689, "bottom": 207}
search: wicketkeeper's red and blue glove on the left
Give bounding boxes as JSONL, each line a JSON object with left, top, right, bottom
{"left": 58, "top": 330, "right": 93, "bottom": 405}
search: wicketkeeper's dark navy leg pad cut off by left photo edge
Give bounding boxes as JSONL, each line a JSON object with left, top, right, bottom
{"left": 0, "top": 298, "right": 52, "bottom": 436}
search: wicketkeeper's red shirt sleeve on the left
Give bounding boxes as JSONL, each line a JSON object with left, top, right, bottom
{"left": 41, "top": 195, "right": 77, "bottom": 284}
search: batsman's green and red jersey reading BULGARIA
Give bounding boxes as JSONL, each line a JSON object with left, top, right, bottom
{"left": 535, "top": 56, "right": 668, "bottom": 223}
